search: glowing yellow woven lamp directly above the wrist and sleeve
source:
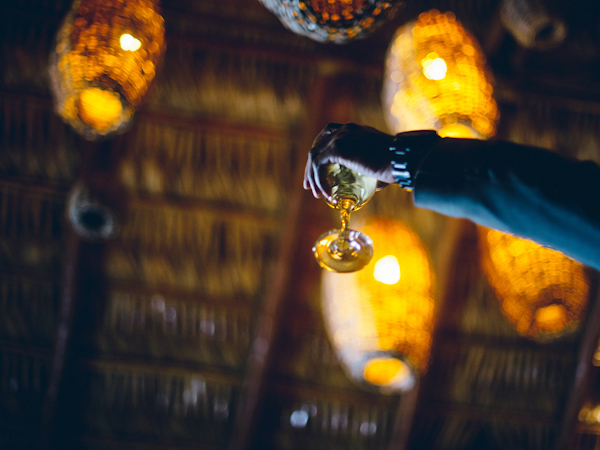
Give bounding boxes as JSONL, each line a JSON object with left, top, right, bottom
{"left": 383, "top": 10, "right": 498, "bottom": 138}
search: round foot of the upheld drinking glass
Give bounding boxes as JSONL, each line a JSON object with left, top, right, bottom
{"left": 313, "top": 230, "right": 373, "bottom": 273}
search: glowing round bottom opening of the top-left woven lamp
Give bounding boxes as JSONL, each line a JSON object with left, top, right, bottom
{"left": 79, "top": 88, "right": 123, "bottom": 130}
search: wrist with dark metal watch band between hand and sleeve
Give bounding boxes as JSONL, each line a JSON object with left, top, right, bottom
{"left": 389, "top": 130, "right": 440, "bottom": 191}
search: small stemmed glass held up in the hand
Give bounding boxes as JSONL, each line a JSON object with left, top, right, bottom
{"left": 312, "top": 164, "right": 377, "bottom": 273}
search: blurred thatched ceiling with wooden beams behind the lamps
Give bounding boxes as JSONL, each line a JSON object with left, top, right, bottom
{"left": 0, "top": 0, "right": 600, "bottom": 450}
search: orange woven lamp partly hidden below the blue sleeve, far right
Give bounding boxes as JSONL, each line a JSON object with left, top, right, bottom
{"left": 480, "top": 228, "right": 589, "bottom": 340}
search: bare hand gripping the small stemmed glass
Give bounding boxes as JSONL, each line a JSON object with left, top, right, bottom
{"left": 304, "top": 123, "right": 395, "bottom": 198}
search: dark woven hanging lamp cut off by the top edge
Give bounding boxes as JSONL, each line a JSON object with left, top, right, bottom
{"left": 260, "top": 0, "right": 403, "bottom": 44}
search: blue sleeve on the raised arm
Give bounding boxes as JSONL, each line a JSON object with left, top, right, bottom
{"left": 413, "top": 138, "right": 600, "bottom": 270}
